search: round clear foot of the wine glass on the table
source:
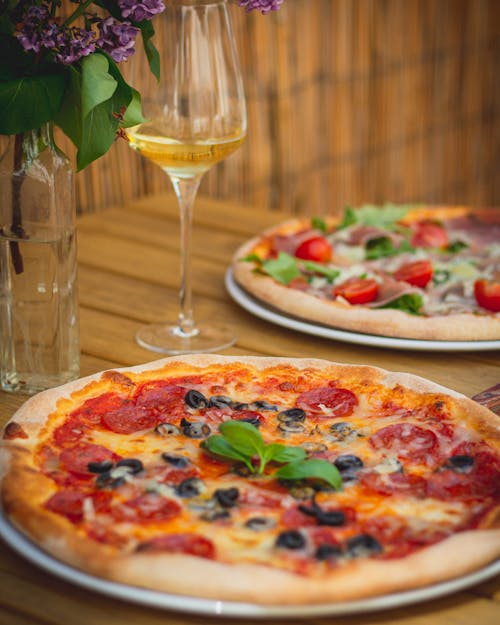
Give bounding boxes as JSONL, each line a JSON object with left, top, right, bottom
{"left": 135, "top": 321, "right": 236, "bottom": 355}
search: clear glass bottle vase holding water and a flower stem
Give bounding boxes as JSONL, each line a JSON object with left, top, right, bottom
{"left": 0, "top": 124, "right": 80, "bottom": 394}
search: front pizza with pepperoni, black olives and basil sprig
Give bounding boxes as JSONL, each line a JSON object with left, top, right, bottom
{"left": 0, "top": 356, "right": 500, "bottom": 605}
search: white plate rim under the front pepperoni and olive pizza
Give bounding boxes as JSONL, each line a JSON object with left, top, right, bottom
{"left": 0, "top": 515, "right": 500, "bottom": 619}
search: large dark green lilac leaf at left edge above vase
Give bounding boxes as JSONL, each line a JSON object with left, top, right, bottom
{"left": 0, "top": 73, "right": 66, "bottom": 135}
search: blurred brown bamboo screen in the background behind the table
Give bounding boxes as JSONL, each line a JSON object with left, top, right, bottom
{"left": 59, "top": 0, "right": 500, "bottom": 214}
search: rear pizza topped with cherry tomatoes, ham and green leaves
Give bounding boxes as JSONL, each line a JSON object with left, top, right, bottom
{"left": 232, "top": 205, "right": 500, "bottom": 341}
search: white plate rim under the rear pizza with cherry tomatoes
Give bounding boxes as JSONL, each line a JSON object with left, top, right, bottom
{"left": 225, "top": 268, "right": 500, "bottom": 352}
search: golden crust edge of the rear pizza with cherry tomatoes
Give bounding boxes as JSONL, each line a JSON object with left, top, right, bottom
{"left": 232, "top": 207, "right": 500, "bottom": 341}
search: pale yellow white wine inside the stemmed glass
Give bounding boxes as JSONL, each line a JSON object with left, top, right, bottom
{"left": 126, "top": 126, "right": 245, "bottom": 178}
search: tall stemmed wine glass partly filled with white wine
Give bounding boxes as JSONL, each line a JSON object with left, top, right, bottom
{"left": 126, "top": 0, "right": 246, "bottom": 354}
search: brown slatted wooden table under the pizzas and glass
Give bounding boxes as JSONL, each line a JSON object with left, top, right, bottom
{"left": 0, "top": 195, "right": 500, "bottom": 625}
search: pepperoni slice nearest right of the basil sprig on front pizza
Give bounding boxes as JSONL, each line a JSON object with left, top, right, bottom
{"left": 368, "top": 423, "right": 439, "bottom": 464}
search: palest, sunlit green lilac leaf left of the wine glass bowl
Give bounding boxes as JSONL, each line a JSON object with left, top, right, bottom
{"left": 81, "top": 54, "right": 118, "bottom": 118}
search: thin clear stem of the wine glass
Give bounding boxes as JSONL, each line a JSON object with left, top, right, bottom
{"left": 170, "top": 174, "right": 203, "bottom": 338}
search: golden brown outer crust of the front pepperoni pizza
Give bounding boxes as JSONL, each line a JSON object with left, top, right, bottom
{"left": 0, "top": 355, "right": 500, "bottom": 605}
